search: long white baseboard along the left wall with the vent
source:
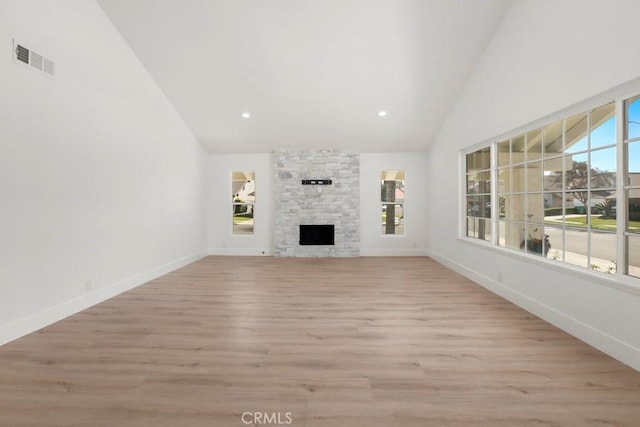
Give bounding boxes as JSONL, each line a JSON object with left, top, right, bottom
{"left": 0, "top": 252, "right": 206, "bottom": 345}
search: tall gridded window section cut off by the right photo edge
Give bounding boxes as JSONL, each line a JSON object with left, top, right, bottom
{"left": 624, "top": 96, "right": 640, "bottom": 277}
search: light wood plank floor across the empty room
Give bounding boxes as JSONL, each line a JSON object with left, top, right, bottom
{"left": 0, "top": 257, "right": 640, "bottom": 427}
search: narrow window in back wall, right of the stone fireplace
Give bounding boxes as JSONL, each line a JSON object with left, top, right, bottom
{"left": 380, "top": 170, "right": 405, "bottom": 235}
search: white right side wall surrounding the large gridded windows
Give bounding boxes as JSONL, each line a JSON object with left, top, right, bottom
{"left": 426, "top": 0, "right": 640, "bottom": 369}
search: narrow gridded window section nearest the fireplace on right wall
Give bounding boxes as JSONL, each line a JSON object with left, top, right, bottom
{"left": 466, "top": 147, "right": 491, "bottom": 241}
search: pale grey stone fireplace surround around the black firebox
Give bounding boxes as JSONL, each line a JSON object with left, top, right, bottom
{"left": 273, "top": 150, "right": 360, "bottom": 257}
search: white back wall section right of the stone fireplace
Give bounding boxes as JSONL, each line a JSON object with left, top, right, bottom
{"left": 360, "top": 153, "right": 430, "bottom": 256}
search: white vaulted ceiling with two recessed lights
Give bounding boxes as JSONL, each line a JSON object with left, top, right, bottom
{"left": 98, "top": 0, "right": 511, "bottom": 153}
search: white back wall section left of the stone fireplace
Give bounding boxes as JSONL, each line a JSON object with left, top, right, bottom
{"left": 207, "top": 154, "right": 273, "bottom": 255}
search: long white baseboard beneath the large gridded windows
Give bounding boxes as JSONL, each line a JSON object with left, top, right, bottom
{"left": 429, "top": 252, "right": 640, "bottom": 371}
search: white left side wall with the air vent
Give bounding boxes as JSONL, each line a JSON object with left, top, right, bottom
{"left": 0, "top": 0, "right": 205, "bottom": 343}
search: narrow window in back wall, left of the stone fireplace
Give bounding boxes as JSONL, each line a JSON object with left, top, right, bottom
{"left": 231, "top": 172, "right": 256, "bottom": 235}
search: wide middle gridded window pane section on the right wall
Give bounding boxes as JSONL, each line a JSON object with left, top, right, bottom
{"left": 497, "top": 103, "right": 617, "bottom": 273}
